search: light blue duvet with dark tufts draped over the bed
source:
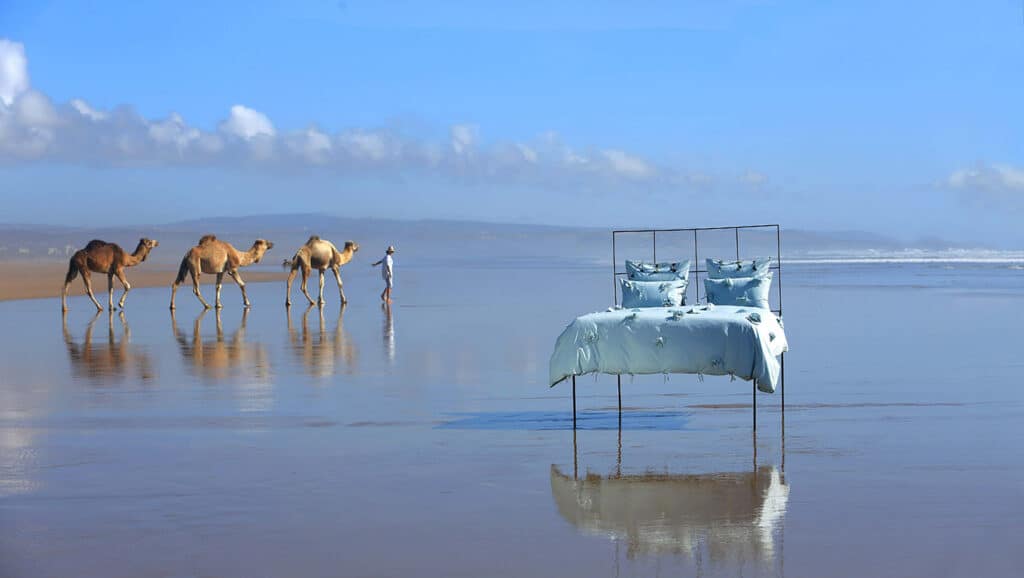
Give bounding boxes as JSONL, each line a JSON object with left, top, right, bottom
{"left": 549, "top": 305, "right": 788, "bottom": 394}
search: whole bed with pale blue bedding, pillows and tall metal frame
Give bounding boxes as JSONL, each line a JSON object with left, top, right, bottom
{"left": 549, "top": 224, "right": 788, "bottom": 429}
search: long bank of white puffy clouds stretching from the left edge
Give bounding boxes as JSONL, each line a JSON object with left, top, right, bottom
{"left": 0, "top": 39, "right": 743, "bottom": 189}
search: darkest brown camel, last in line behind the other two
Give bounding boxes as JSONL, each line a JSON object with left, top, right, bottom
{"left": 60, "top": 237, "right": 160, "bottom": 312}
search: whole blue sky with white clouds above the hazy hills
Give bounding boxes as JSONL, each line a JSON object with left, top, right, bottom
{"left": 0, "top": 0, "right": 1024, "bottom": 248}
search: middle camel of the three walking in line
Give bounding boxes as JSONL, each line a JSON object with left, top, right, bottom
{"left": 171, "top": 235, "right": 273, "bottom": 309}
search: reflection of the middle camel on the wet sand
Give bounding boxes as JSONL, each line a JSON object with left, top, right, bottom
{"left": 171, "top": 309, "right": 270, "bottom": 383}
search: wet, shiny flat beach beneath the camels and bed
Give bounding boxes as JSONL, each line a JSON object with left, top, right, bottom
{"left": 0, "top": 255, "right": 1024, "bottom": 578}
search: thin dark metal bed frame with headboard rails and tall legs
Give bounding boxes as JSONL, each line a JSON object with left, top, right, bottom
{"left": 572, "top": 224, "right": 785, "bottom": 431}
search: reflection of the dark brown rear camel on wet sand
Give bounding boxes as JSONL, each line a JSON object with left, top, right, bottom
{"left": 61, "top": 311, "right": 154, "bottom": 384}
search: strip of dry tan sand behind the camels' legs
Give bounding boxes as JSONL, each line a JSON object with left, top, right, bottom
{"left": 0, "top": 261, "right": 287, "bottom": 302}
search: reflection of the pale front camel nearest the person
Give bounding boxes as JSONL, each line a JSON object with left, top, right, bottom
{"left": 287, "top": 305, "right": 358, "bottom": 377}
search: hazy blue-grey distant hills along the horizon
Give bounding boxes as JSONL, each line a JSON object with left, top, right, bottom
{"left": 0, "top": 214, "right": 1016, "bottom": 266}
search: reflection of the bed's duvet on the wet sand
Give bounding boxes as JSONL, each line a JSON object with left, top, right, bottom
{"left": 551, "top": 432, "right": 790, "bottom": 564}
